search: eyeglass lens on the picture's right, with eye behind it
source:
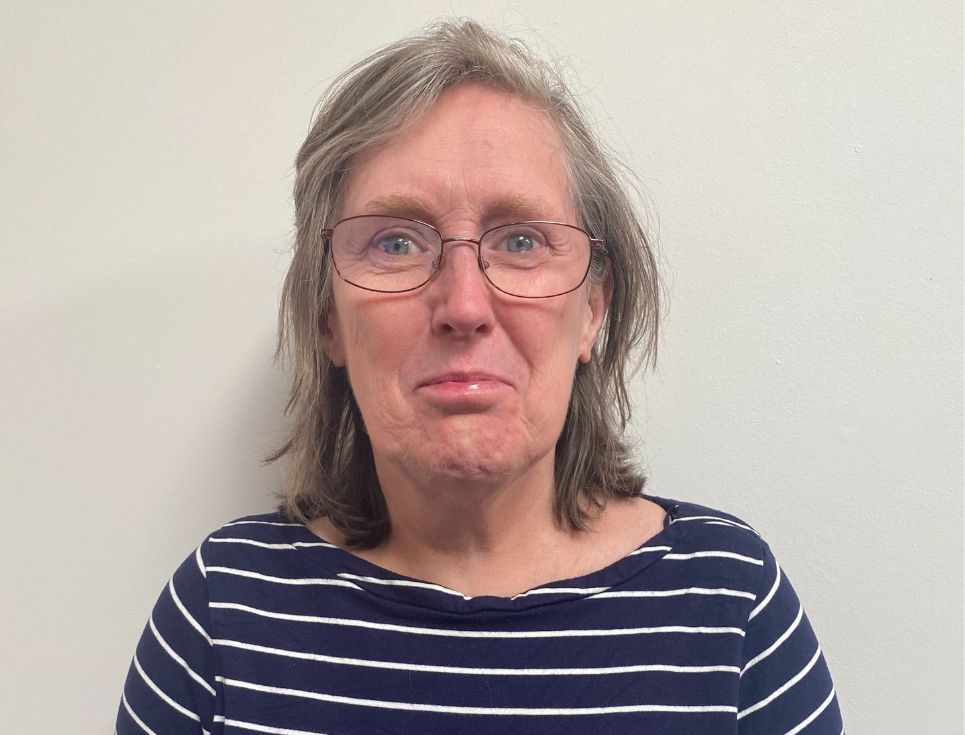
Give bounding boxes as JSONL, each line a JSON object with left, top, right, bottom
{"left": 480, "top": 222, "right": 592, "bottom": 298}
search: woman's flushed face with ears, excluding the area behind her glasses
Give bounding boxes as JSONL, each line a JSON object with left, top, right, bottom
{"left": 322, "top": 84, "right": 607, "bottom": 489}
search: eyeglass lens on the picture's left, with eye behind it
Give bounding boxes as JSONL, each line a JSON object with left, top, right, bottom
{"left": 332, "top": 215, "right": 442, "bottom": 292}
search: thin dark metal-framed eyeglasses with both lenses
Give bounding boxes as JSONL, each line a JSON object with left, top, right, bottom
{"left": 322, "top": 214, "right": 606, "bottom": 299}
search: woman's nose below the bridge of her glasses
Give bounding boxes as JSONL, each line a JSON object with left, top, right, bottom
{"left": 426, "top": 238, "right": 495, "bottom": 337}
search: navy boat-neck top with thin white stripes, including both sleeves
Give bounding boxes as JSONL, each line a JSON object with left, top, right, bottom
{"left": 116, "top": 497, "right": 844, "bottom": 735}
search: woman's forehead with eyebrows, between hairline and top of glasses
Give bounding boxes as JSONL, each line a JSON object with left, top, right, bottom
{"left": 341, "top": 84, "right": 574, "bottom": 221}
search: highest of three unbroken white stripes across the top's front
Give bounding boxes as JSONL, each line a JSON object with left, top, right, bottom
{"left": 211, "top": 602, "right": 744, "bottom": 638}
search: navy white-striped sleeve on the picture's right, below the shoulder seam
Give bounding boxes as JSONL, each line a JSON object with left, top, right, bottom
{"left": 737, "top": 544, "right": 844, "bottom": 735}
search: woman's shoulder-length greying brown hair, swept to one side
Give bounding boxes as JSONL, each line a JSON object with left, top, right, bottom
{"left": 266, "top": 20, "right": 659, "bottom": 547}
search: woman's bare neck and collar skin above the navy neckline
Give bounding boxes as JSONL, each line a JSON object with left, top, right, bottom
{"left": 310, "top": 455, "right": 665, "bottom": 597}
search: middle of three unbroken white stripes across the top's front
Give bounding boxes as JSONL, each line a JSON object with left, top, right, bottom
{"left": 215, "top": 639, "right": 738, "bottom": 676}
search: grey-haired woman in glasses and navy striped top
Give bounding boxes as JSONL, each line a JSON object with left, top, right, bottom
{"left": 117, "top": 23, "right": 842, "bottom": 735}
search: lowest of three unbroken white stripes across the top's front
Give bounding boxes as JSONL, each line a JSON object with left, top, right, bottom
{"left": 225, "top": 679, "right": 737, "bottom": 717}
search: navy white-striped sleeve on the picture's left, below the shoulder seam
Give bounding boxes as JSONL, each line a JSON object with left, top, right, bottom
{"left": 116, "top": 545, "right": 216, "bottom": 735}
